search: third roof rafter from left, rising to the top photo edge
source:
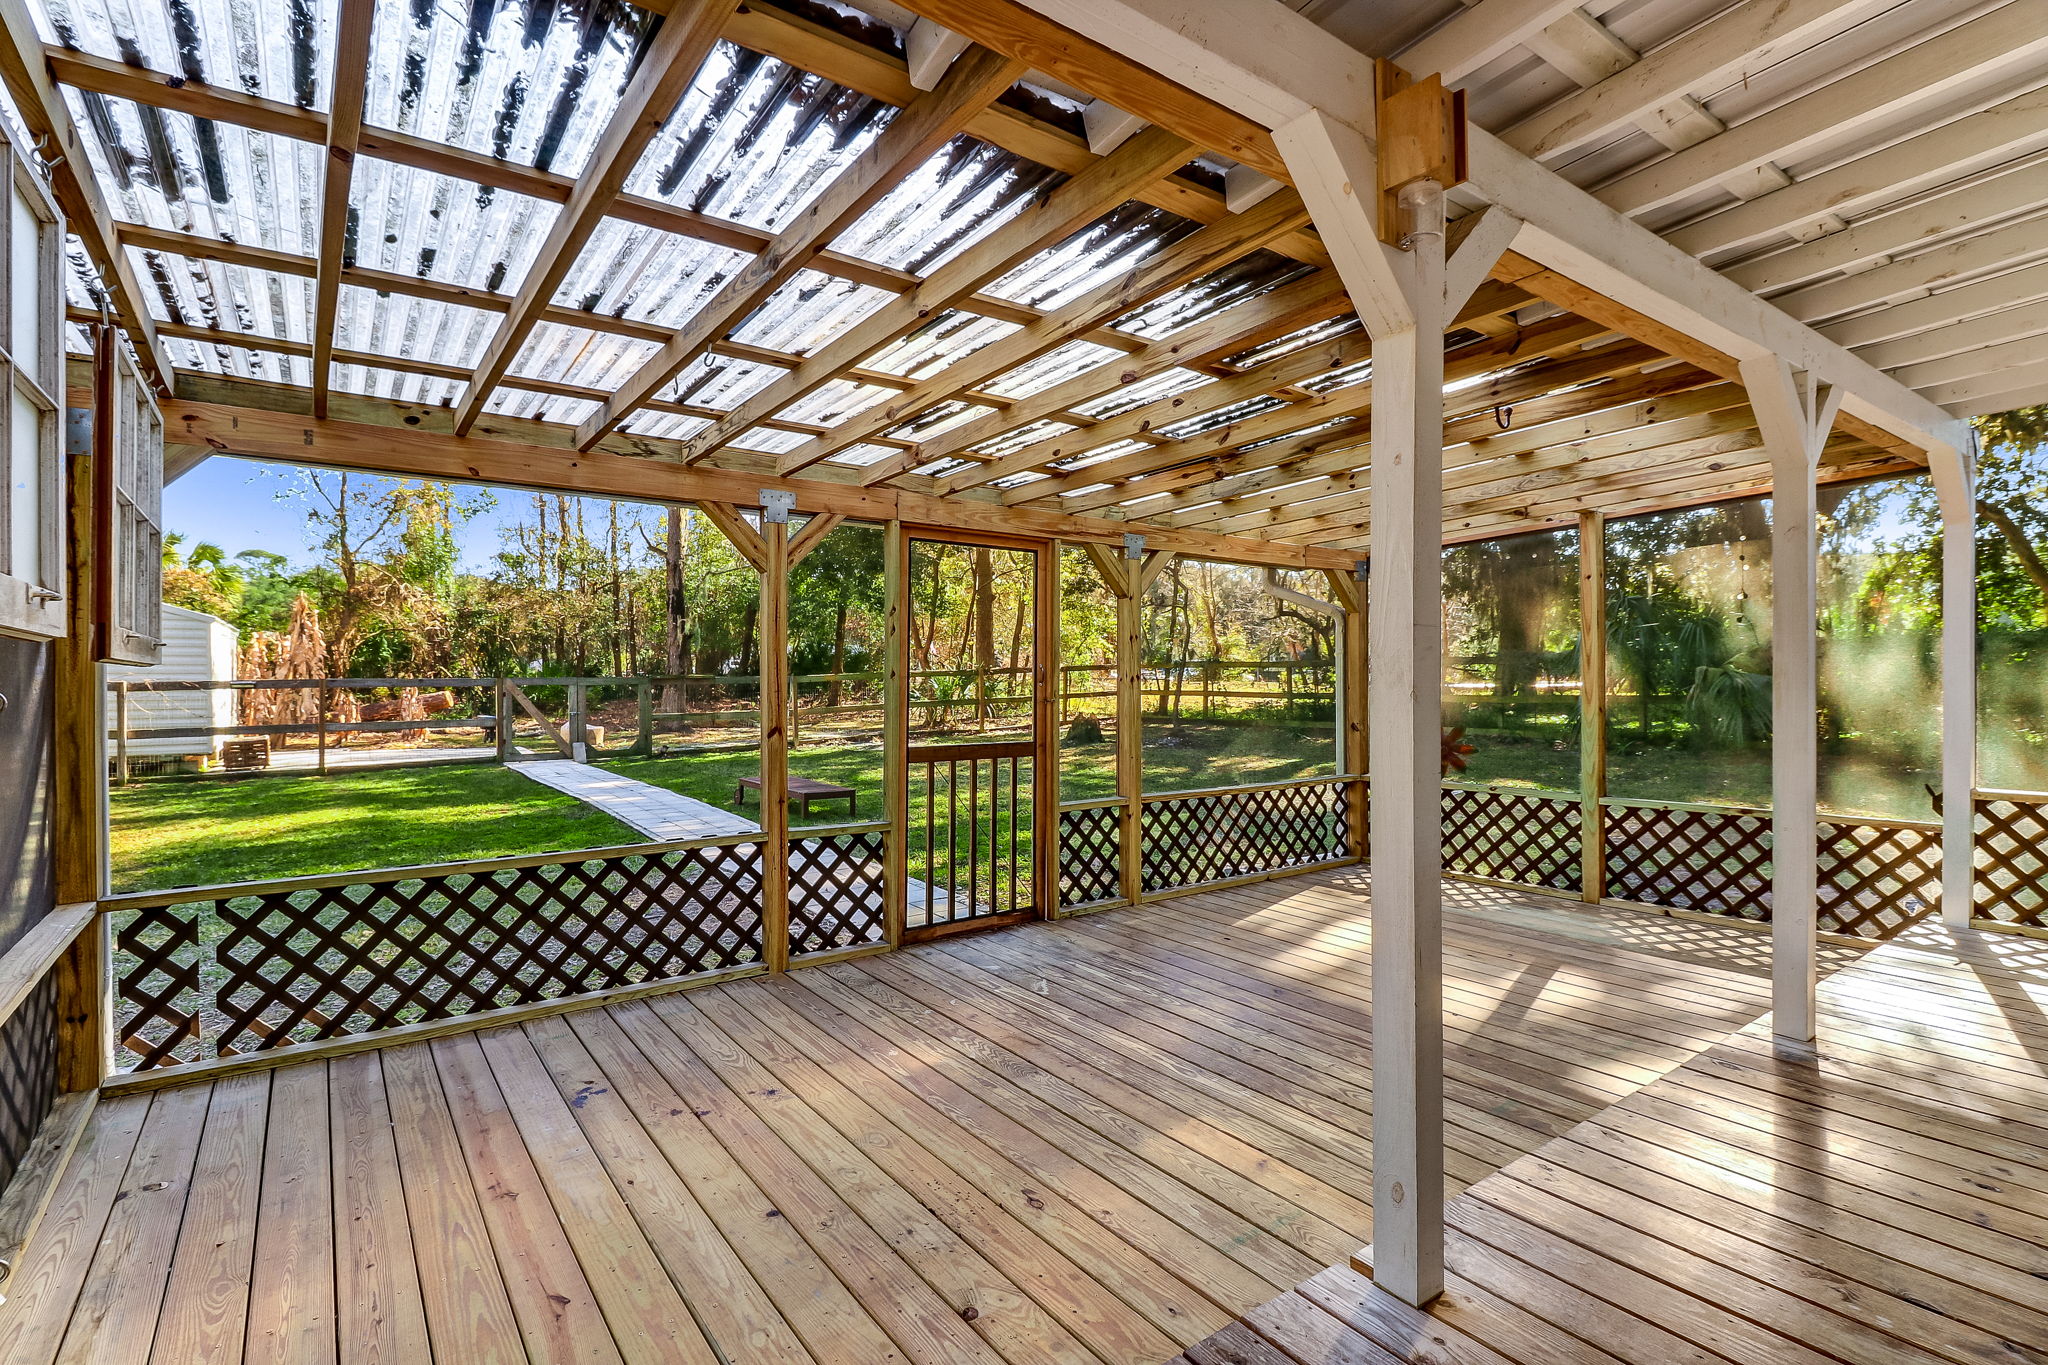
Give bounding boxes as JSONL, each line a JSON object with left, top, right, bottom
{"left": 455, "top": 0, "right": 737, "bottom": 434}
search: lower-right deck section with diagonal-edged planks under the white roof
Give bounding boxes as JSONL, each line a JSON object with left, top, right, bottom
{"left": 1184, "top": 912, "right": 2048, "bottom": 1365}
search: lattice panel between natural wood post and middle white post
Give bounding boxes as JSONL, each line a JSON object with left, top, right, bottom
{"left": 1604, "top": 806, "right": 1772, "bottom": 921}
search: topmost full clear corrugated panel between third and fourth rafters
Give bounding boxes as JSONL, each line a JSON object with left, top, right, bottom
{"left": 627, "top": 43, "right": 895, "bottom": 231}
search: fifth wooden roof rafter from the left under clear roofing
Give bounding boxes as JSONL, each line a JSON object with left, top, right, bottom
{"left": 663, "top": 131, "right": 1194, "bottom": 470}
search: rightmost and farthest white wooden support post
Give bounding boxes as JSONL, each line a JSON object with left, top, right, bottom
{"left": 1929, "top": 470, "right": 1976, "bottom": 929}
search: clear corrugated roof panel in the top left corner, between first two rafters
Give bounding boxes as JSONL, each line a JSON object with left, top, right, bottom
{"left": 31, "top": 0, "right": 340, "bottom": 108}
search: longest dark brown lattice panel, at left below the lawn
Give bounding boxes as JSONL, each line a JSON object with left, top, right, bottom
{"left": 106, "top": 841, "right": 762, "bottom": 1070}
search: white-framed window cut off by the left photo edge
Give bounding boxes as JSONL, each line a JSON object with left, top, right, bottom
{"left": 0, "top": 127, "right": 66, "bottom": 636}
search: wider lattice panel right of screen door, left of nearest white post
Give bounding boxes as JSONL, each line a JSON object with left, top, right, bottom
{"left": 1141, "top": 778, "right": 1352, "bottom": 892}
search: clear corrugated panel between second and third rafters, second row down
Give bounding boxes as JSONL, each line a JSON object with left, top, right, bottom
{"left": 346, "top": 156, "right": 561, "bottom": 295}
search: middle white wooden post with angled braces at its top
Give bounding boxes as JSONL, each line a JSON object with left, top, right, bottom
{"left": 1741, "top": 356, "right": 1841, "bottom": 1044}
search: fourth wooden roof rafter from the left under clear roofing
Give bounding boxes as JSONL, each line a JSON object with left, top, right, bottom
{"left": 578, "top": 47, "right": 1024, "bottom": 450}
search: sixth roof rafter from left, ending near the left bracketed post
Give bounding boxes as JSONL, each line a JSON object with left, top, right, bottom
{"left": 827, "top": 190, "right": 1309, "bottom": 483}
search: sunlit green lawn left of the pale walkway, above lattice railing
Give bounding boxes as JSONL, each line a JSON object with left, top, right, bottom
{"left": 111, "top": 763, "right": 643, "bottom": 890}
